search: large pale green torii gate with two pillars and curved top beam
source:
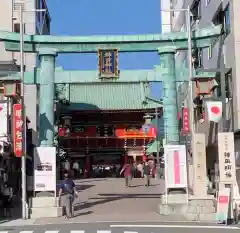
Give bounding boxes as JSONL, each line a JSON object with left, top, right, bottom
{"left": 0, "top": 26, "right": 221, "bottom": 146}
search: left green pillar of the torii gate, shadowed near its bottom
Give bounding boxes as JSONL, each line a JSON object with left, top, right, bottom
{"left": 39, "top": 49, "right": 57, "bottom": 146}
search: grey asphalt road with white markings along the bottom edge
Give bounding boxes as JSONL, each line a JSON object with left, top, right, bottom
{"left": 0, "top": 222, "right": 240, "bottom": 233}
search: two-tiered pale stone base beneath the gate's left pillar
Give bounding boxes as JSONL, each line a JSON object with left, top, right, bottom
{"left": 29, "top": 197, "right": 63, "bottom": 219}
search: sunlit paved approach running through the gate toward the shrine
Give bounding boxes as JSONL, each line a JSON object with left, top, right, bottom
{"left": 35, "top": 178, "right": 174, "bottom": 224}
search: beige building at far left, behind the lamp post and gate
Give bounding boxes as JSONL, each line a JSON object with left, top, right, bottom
{"left": 0, "top": 0, "right": 51, "bottom": 144}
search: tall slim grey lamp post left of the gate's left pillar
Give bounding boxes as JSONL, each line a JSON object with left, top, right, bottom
{"left": 15, "top": 1, "right": 46, "bottom": 219}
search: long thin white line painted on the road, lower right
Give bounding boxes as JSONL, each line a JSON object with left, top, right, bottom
{"left": 110, "top": 225, "right": 240, "bottom": 230}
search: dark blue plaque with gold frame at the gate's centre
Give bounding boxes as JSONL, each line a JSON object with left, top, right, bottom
{"left": 98, "top": 49, "right": 119, "bottom": 78}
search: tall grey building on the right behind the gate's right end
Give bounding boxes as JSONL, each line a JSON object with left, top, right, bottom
{"left": 161, "top": 0, "right": 240, "bottom": 173}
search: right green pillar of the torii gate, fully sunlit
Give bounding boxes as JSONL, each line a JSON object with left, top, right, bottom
{"left": 158, "top": 47, "right": 180, "bottom": 144}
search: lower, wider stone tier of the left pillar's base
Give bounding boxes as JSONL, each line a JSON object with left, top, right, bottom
{"left": 30, "top": 207, "right": 63, "bottom": 219}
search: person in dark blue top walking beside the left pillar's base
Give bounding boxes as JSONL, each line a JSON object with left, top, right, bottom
{"left": 59, "top": 171, "right": 78, "bottom": 218}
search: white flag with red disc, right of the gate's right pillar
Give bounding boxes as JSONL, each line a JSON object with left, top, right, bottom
{"left": 206, "top": 101, "right": 222, "bottom": 123}
